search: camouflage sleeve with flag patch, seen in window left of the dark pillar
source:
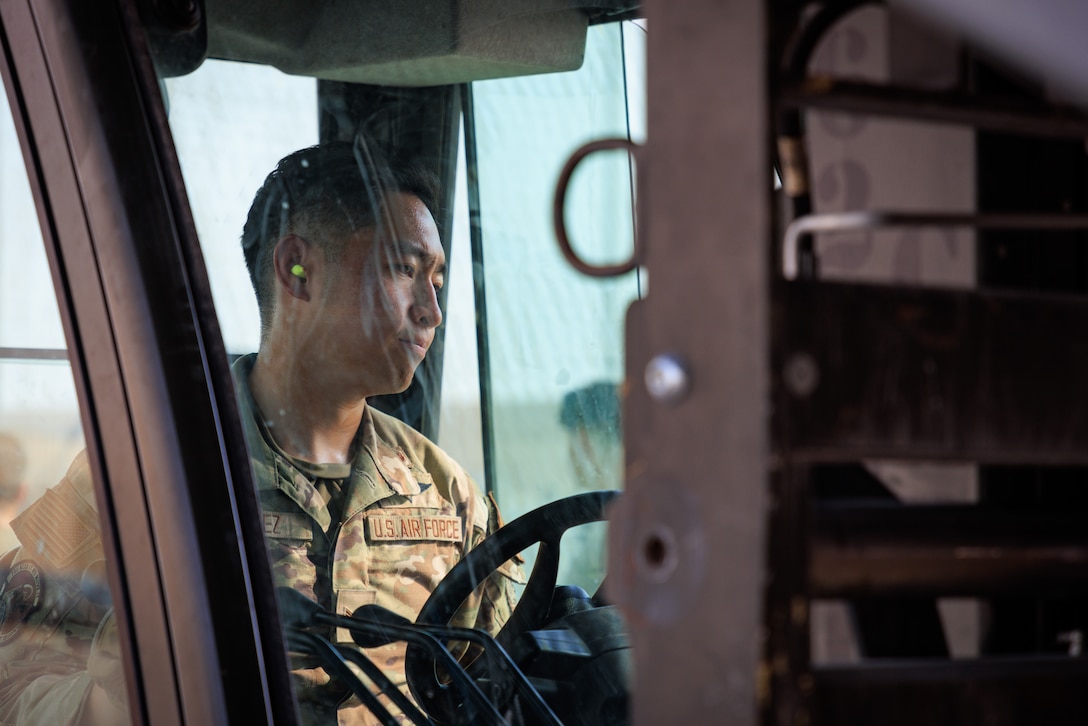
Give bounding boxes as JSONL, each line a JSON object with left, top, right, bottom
{"left": 0, "top": 452, "right": 128, "bottom": 726}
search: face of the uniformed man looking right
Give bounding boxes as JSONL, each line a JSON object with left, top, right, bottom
{"left": 313, "top": 193, "right": 446, "bottom": 396}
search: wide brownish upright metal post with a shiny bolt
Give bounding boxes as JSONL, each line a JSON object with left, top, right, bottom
{"left": 609, "top": 0, "right": 771, "bottom": 726}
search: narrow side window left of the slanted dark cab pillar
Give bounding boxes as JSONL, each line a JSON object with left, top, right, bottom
{"left": 0, "top": 74, "right": 129, "bottom": 724}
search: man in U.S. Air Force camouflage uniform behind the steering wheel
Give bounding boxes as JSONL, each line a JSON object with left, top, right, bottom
{"left": 235, "top": 143, "right": 519, "bottom": 724}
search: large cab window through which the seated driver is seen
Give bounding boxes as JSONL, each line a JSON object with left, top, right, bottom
{"left": 162, "top": 11, "right": 646, "bottom": 723}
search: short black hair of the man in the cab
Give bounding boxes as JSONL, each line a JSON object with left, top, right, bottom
{"left": 242, "top": 137, "right": 440, "bottom": 337}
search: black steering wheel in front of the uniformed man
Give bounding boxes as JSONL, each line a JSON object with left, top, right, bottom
{"left": 405, "top": 491, "right": 619, "bottom": 723}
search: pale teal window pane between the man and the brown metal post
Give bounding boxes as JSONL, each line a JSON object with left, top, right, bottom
{"left": 473, "top": 23, "right": 645, "bottom": 592}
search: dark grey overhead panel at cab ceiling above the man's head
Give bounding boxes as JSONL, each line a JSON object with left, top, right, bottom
{"left": 207, "top": 0, "right": 588, "bottom": 86}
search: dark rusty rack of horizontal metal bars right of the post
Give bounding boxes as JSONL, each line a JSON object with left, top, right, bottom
{"left": 762, "top": 3, "right": 1088, "bottom": 725}
